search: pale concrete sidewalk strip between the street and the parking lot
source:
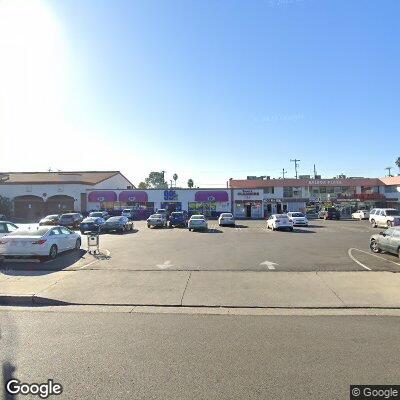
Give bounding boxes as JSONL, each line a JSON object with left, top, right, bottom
{"left": 0, "top": 270, "right": 400, "bottom": 308}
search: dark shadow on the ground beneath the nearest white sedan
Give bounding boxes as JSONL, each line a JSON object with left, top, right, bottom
{"left": 0, "top": 249, "right": 91, "bottom": 276}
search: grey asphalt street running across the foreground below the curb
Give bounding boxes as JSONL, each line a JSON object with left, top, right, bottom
{"left": 0, "top": 310, "right": 400, "bottom": 400}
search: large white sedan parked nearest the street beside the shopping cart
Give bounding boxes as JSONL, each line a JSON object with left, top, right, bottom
{"left": 0, "top": 226, "right": 81, "bottom": 259}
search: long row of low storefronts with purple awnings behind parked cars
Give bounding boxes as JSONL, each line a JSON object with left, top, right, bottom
{"left": 0, "top": 171, "right": 400, "bottom": 219}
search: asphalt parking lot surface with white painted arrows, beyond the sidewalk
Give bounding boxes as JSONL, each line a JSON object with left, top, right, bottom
{"left": 3, "top": 220, "right": 400, "bottom": 272}
